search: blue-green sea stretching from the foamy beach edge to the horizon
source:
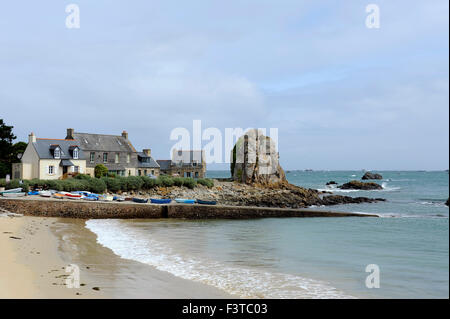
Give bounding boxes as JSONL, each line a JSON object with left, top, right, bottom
{"left": 86, "top": 170, "right": 449, "bottom": 298}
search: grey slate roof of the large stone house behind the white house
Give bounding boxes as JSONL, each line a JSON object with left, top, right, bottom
{"left": 73, "top": 132, "right": 136, "bottom": 153}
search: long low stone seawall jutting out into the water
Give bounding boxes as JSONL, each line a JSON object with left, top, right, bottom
{"left": 0, "top": 198, "right": 378, "bottom": 219}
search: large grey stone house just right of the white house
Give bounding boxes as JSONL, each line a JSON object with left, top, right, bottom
{"left": 66, "top": 128, "right": 159, "bottom": 176}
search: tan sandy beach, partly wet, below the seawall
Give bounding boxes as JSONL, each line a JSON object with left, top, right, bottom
{"left": 0, "top": 216, "right": 235, "bottom": 299}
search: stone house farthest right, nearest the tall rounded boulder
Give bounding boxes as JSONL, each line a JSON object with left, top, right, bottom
{"left": 157, "top": 150, "right": 206, "bottom": 178}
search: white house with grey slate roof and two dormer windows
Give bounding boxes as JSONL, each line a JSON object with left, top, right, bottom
{"left": 13, "top": 133, "right": 86, "bottom": 179}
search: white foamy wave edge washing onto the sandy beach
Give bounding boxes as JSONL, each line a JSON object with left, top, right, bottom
{"left": 86, "top": 219, "right": 353, "bottom": 298}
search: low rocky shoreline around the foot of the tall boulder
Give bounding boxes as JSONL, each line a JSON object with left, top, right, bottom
{"left": 114, "top": 180, "right": 384, "bottom": 208}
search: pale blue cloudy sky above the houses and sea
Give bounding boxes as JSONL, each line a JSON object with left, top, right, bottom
{"left": 0, "top": 0, "right": 449, "bottom": 170}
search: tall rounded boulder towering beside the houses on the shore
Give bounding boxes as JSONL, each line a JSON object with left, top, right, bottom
{"left": 231, "top": 129, "right": 286, "bottom": 184}
